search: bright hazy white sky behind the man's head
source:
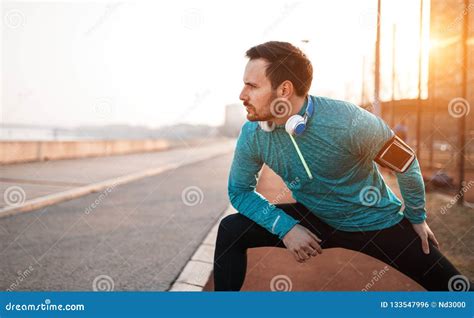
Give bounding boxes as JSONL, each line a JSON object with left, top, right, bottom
{"left": 0, "top": 0, "right": 429, "bottom": 128}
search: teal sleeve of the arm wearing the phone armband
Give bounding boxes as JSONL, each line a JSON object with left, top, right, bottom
{"left": 351, "top": 109, "right": 426, "bottom": 224}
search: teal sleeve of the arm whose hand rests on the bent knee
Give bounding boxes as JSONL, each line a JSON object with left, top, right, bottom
{"left": 228, "top": 123, "right": 298, "bottom": 239}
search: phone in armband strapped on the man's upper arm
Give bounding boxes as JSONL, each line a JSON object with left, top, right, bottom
{"left": 374, "top": 135, "right": 416, "bottom": 173}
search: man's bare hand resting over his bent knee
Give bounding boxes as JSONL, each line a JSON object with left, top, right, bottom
{"left": 283, "top": 224, "right": 323, "bottom": 263}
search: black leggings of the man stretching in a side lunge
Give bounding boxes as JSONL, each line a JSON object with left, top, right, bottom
{"left": 214, "top": 203, "right": 472, "bottom": 291}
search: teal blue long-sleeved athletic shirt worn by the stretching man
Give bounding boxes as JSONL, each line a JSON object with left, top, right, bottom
{"left": 228, "top": 95, "right": 426, "bottom": 238}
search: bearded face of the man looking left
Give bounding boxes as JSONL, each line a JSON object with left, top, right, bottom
{"left": 239, "top": 59, "right": 276, "bottom": 121}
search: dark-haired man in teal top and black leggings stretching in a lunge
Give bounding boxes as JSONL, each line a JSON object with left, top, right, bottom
{"left": 214, "top": 42, "right": 469, "bottom": 291}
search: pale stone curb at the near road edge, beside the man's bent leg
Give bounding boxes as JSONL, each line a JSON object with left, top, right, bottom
{"left": 169, "top": 206, "right": 237, "bottom": 291}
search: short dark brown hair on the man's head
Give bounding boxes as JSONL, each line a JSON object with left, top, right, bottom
{"left": 246, "top": 41, "right": 313, "bottom": 96}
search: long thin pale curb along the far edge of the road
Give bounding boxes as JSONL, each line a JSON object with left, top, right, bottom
{"left": 0, "top": 152, "right": 227, "bottom": 218}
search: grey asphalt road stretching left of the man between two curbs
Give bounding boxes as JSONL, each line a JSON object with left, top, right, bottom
{"left": 0, "top": 154, "right": 232, "bottom": 291}
